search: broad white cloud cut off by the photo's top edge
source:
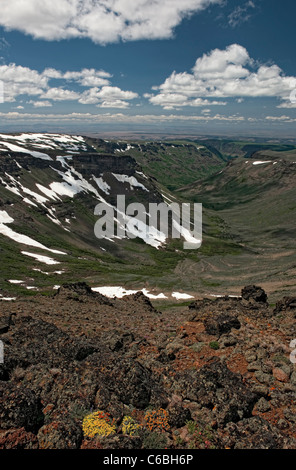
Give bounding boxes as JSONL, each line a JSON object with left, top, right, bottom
{"left": 0, "top": 0, "right": 222, "bottom": 44}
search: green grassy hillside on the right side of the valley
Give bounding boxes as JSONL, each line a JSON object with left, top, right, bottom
{"left": 175, "top": 151, "right": 296, "bottom": 300}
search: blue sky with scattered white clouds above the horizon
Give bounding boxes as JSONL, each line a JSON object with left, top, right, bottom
{"left": 0, "top": 0, "right": 296, "bottom": 138}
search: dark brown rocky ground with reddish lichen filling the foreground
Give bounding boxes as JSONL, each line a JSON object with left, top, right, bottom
{"left": 0, "top": 283, "right": 296, "bottom": 449}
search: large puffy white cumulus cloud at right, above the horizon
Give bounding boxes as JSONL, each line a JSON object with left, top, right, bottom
{"left": 147, "top": 44, "right": 296, "bottom": 109}
